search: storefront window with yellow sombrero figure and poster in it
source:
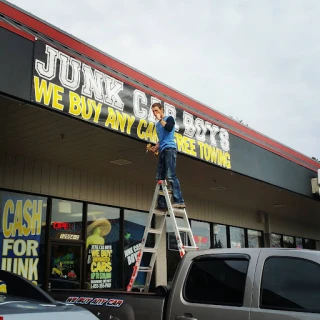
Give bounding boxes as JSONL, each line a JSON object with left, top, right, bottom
{"left": 85, "top": 204, "right": 122, "bottom": 289}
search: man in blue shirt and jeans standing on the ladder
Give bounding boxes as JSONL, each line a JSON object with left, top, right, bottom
{"left": 151, "top": 102, "right": 186, "bottom": 211}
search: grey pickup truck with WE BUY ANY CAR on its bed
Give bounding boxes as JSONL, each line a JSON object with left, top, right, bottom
{"left": 50, "top": 248, "right": 320, "bottom": 320}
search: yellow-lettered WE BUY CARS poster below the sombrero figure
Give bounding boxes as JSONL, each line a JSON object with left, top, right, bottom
{"left": 89, "top": 245, "right": 112, "bottom": 289}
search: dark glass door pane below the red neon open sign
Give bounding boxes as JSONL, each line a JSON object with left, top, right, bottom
{"left": 49, "top": 244, "right": 81, "bottom": 289}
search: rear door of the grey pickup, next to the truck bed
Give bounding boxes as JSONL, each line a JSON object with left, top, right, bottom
{"left": 168, "top": 249, "right": 258, "bottom": 320}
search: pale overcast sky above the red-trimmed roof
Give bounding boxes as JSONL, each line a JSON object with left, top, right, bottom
{"left": 6, "top": 0, "right": 320, "bottom": 158}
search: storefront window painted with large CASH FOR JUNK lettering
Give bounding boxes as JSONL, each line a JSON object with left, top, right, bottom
{"left": 0, "top": 191, "right": 47, "bottom": 286}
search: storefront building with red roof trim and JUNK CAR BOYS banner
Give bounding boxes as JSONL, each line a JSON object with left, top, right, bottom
{"left": 0, "top": 2, "right": 320, "bottom": 290}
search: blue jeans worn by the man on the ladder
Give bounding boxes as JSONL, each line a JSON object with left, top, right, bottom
{"left": 156, "top": 148, "right": 184, "bottom": 208}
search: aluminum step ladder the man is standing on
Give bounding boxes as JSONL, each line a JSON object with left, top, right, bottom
{"left": 127, "top": 180, "right": 198, "bottom": 292}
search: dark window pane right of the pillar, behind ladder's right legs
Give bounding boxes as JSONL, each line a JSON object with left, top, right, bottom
{"left": 166, "top": 217, "right": 188, "bottom": 284}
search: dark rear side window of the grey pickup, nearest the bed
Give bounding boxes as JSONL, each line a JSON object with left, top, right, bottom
{"left": 184, "top": 257, "right": 249, "bottom": 306}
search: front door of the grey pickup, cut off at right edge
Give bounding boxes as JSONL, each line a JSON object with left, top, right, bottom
{"left": 251, "top": 250, "right": 320, "bottom": 320}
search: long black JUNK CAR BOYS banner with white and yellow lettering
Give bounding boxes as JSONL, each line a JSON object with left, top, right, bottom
{"left": 31, "top": 40, "right": 231, "bottom": 169}
